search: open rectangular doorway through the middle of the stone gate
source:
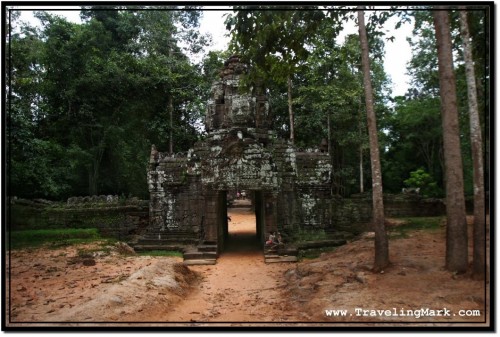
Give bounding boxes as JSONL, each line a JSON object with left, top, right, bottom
{"left": 222, "top": 190, "right": 263, "bottom": 252}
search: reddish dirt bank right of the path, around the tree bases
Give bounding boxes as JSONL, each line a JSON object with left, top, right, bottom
{"left": 285, "top": 215, "right": 490, "bottom": 327}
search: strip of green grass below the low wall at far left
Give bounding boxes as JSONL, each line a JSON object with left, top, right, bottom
{"left": 6, "top": 228, "right": 101, "bottom": 249}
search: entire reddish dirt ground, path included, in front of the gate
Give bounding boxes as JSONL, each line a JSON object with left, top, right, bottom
{"left": 2, "top": 209, "right": 490, "bottom": 328}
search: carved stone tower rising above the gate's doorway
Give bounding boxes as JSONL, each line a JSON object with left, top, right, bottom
{"left": 201, "top": 56, "right": 279, "bottom": 191}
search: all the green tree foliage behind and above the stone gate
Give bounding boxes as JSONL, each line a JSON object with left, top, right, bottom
{"left": 5, "top": 5, "right": 491, "bottom": 200}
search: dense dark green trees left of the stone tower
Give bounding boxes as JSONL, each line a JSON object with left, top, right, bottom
{"left": 7, "top": 6, "right": 212, "bottom": 200}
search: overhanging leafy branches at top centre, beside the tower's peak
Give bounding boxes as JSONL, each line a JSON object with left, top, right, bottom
{"left": 226, "top": 6, "right": 323, "bottom": 76}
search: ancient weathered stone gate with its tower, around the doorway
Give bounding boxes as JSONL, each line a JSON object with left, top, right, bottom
{"left": 139, "top": 56, "right": 334, "bottom": 262}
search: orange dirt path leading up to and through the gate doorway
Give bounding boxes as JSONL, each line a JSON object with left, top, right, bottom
{"left": 134, "top": 208, "right": 292, "bottom": 322}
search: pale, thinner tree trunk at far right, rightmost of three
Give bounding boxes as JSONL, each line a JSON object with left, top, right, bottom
{"left": 460, "top": 7, "right": 486, "bottom": 279}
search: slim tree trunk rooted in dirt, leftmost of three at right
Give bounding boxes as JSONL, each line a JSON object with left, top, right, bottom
{"left": 358, "top": 6, "right": 389, "bottom": 271}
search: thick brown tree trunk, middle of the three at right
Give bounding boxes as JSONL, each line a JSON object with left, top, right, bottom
{"left": 433, "top": 6, "right": 468, "bottom": 273}
